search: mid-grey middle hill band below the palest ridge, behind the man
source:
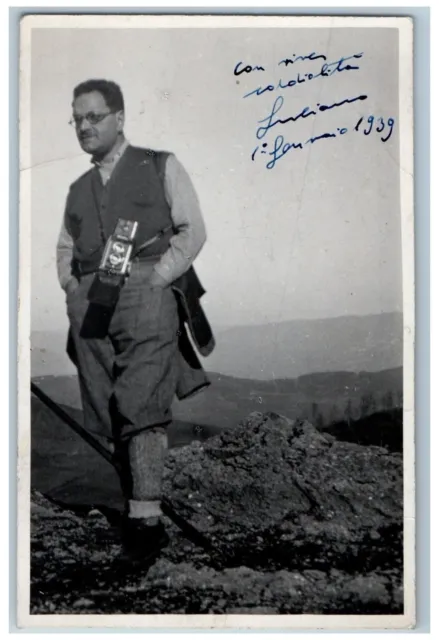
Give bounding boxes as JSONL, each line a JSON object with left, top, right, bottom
{"left": 30, "top": 368, "right": 402, "bottom": 436}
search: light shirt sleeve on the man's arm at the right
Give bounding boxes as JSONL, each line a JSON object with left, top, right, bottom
{"left": 154, "top": 154, "right": 206, "bottom": 284}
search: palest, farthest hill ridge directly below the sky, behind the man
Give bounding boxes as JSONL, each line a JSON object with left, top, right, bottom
{"left": 32, "top": 312, "right": 403, "bottom": 380}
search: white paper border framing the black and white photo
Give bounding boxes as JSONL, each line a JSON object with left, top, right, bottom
{"left": 17, "top": 15, "right": 415, "bottom": 630}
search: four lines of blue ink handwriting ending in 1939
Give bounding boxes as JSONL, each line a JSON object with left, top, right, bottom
{"left": 234, "top": 51, "right": 395, "bottom": 169}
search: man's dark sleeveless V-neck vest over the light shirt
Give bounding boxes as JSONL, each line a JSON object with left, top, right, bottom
{"left": 65, "top": 146, "right": 173, "bottom": 272}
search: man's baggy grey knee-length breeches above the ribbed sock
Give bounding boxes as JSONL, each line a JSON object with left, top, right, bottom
{"left": 67, "top": 263, "right": 179, "bottom": 440}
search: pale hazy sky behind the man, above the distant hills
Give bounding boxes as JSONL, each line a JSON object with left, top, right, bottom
{"left": 26, "top": 24, "right": 402, "bottom": 330}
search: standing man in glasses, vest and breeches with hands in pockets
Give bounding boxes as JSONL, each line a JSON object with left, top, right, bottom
{"left": 57, "top": 80, "right": 212, "bottom": 559}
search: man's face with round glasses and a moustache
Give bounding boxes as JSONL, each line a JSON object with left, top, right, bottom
{"left": 73, "top": 91, "right": 124, "bottom": 156}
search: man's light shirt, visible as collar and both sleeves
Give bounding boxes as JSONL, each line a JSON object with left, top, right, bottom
{"left": 56, "top": 140, "right": 206, "bottom": 290}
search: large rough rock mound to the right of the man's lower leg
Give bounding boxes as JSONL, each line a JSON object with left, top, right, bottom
{"left": 166, "top": 413, "right": 403, "bottom": 571}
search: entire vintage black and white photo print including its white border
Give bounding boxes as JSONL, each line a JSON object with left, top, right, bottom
{"left": 18, "top": 15, "right": 415, "bottom": 629}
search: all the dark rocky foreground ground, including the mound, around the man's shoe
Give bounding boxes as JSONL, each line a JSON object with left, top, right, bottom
{"left": 31, "top": 414, "right": 403, "bottom": 615}
